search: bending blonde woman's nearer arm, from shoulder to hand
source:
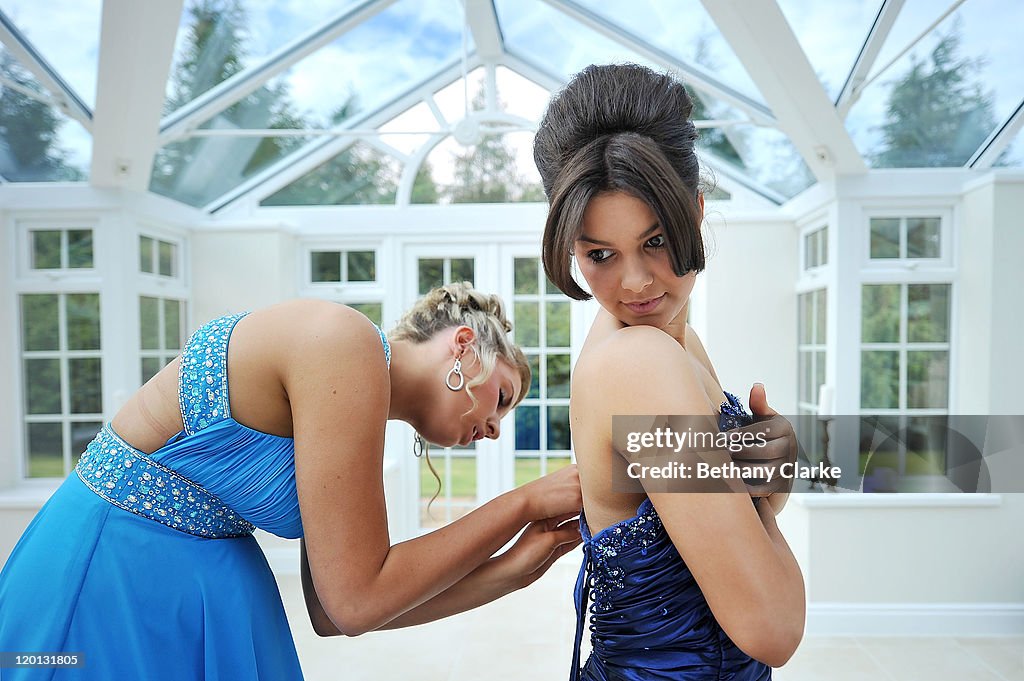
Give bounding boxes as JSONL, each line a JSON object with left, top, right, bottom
{"left": 283, "top": 304, "right": 581, "bottom": 635}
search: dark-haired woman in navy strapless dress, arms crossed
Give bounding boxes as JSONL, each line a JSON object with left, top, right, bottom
{"left": 535, "top": 65, "right": 805, "bottom": 680}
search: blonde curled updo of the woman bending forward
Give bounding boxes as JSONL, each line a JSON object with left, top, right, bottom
{"left": 388, "top": 282, "right": 530, "bottom": 407}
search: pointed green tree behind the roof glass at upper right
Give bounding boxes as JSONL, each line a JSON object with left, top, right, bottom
{"left": 872, "top": 24, "right": 995, "bottom": 168}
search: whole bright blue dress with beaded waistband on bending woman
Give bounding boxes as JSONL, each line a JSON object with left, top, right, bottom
{"left": 0, "top": 314, "right": 390, "bottom": 681}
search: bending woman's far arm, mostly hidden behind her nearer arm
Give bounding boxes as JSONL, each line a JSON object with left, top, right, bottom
{"left": 301, "top": 520, "right": 581, "bottom": 636}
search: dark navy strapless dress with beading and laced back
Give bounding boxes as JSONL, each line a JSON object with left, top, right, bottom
{"left": 569, "top": 392, "right": 771, "bottom": 681}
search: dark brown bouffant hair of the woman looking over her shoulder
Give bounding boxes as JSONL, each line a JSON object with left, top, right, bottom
{"left": 534, "top": 63, "right": 705, "bottom": 300}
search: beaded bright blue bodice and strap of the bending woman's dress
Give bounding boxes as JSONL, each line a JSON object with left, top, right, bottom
{"left": 78, "top": 313, "right": 391, "bottom": 539}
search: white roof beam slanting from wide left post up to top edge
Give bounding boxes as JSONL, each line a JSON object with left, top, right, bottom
{"left": 160, "top": 0, "right": 395, "bottom": 146}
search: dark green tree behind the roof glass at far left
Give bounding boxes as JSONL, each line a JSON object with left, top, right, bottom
{"left": 0, "top": 51, "right": 85, "bottom": 182}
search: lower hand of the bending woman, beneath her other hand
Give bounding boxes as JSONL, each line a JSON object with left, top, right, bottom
{"left": 494, "top": 514, "right": 582, "bottom": 589}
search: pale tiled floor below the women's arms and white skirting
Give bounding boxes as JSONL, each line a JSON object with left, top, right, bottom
{"left": 279, "top": 552, "right": 1024, "bottom": 681}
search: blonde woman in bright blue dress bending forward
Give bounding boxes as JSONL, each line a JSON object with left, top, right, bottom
{"left": 0, "top": 284, "right": 582, "bottom": 681}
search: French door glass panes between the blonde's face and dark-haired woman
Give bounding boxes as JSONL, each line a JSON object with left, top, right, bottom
{"left": 512, "top": 257, "right": 571, "bottom": 485}
